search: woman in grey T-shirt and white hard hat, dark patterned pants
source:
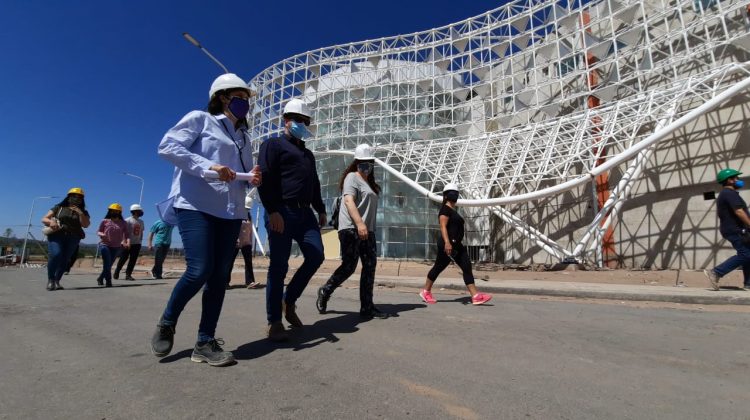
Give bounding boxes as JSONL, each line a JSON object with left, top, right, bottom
{"left": 316, "top": 144, "right": 388, "bottom": 319}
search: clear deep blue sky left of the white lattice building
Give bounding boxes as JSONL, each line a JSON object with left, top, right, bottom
{"left": 0, "top": 0, "right": 504, "bottom": 246}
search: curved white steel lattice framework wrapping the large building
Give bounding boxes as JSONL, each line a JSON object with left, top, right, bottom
{"left": 251, "top": 0, "right": 750, "bottom": 260}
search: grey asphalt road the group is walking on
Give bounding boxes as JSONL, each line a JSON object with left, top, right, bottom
{"left": 0, "top": 269, "right": 750, "bottom": 419}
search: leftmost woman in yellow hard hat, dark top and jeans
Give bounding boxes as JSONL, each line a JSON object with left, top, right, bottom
{"left": 42, "top": 187, "right": 91, "bottom": 291}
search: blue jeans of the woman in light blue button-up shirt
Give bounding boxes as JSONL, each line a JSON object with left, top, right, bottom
{"left": 162, "top": 209, "right": 242, "bottom": 342}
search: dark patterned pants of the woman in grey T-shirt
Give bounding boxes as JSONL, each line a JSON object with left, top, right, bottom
{"left": 323, "top": 229, "right": 378, "bottom": 312}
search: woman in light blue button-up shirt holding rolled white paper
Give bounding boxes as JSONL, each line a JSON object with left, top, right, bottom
{"left": 151, "top": 73, "right": 261, "bottom": 366}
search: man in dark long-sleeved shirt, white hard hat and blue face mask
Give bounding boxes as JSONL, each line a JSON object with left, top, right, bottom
{"left": 258, "top": 99, "right": 326, "bottom": 341}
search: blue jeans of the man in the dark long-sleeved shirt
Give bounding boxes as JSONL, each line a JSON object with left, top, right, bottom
{"left": 263, "top": 206, "right": 325, "bottom": 323}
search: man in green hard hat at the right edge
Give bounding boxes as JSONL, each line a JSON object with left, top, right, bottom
{"left": 703, "top": 169, "right": 750, "bottom": 290}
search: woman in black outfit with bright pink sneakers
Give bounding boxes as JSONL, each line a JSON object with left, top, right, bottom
{"left": 419, "top": 183, "right": 492, "bottom": 305}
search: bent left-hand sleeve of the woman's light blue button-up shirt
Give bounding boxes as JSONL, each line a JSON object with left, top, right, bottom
{"left": 159, "top": 111, "right": 215, "bottom": 177}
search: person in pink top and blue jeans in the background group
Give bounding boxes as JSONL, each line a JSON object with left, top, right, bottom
{"left": 96, "top": 203, "right": 130, "bottom": 287}
